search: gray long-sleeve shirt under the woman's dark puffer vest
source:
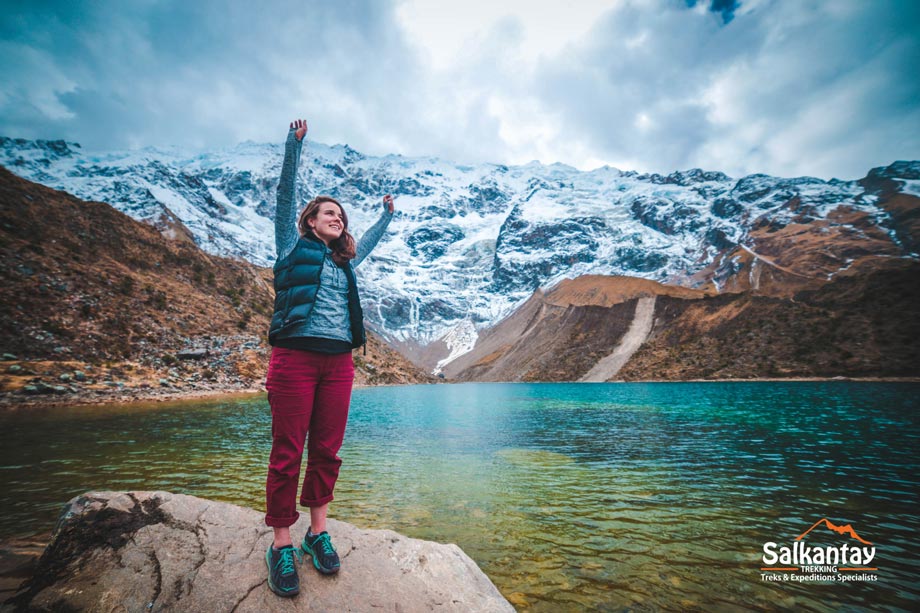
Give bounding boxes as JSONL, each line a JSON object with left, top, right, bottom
{"left": 275, "top": 129, "right": 393, "bottom": 343}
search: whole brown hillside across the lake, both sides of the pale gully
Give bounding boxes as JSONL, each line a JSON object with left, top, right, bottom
{"left": 444, "top": 258, "right": 920, "bottom": 381}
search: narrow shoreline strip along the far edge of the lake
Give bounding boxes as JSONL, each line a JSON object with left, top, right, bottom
{"left": 0, "top": 376, "right": 920, "bottom": 411}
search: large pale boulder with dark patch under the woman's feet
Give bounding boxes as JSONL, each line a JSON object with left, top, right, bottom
{"left": 0, "top": 492, "right": 514, "bottom": 613}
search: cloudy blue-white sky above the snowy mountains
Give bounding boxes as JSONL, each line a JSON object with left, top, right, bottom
{"left": 0, "top": 0, "right": 920, "bottom": 179}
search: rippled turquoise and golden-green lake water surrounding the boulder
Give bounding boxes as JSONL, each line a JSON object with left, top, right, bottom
{"left": 0, "top": 382, "right": 920, "bottom": 611}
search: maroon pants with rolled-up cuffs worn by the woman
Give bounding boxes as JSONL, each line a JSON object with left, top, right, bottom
{"left": 265, "top": 347, "right": 355, "bottom": 528}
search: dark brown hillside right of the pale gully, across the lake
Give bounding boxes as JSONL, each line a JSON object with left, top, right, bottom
{"left": 617, "top": 259, "right": 920, "bottom": 380}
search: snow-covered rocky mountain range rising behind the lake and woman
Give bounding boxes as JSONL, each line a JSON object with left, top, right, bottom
{"left": 0, "top": 138, "right": 920, "bottom": 356}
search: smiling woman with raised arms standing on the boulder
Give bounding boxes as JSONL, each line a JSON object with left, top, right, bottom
{"left": 265, "top": 119, "right": 393, "bottom": 596}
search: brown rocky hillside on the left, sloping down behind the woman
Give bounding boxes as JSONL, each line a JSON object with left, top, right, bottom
{"left": 0, "top": 168, "right": 430, "bottom": 403}
